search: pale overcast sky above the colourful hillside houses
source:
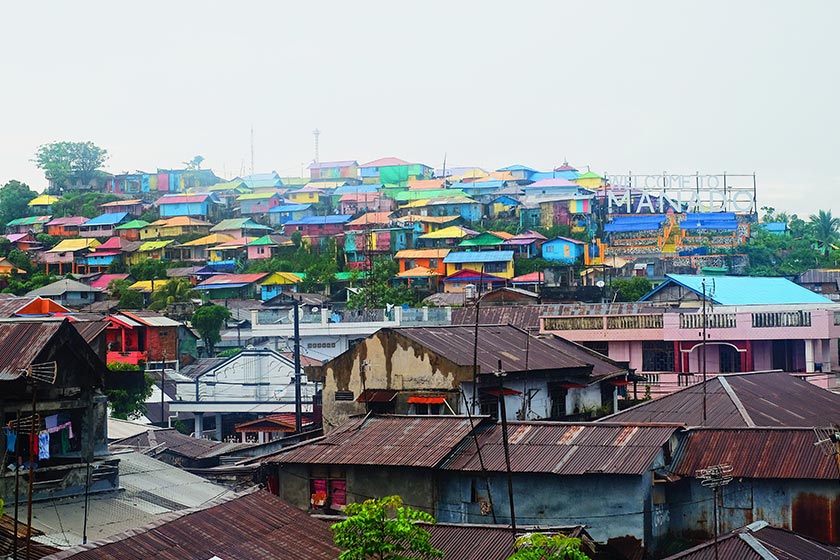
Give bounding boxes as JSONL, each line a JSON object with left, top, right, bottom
{"left": 0, "top": 0, "right": 840, "bottom": 215}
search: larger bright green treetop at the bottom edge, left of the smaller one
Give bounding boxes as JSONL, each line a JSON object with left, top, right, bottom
{"left": 331, "top": 496, "right": 443, "bottom": 560}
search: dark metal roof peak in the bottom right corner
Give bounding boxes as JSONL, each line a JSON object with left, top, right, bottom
{"left": 664, "top": 521, "right": 840, "bottom": 560}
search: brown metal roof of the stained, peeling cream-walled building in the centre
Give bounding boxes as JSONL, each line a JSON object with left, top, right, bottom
{"left": 394, "top": 325, "right": 627, "bottom": 378}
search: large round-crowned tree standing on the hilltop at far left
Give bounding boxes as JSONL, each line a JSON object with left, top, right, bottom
{"left": 33, "top": 142, "right": 108, "bottom": 188}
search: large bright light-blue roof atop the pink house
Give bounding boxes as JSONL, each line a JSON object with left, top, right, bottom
{"left": 639, "top": 274, "right": 832, "bottom": 305}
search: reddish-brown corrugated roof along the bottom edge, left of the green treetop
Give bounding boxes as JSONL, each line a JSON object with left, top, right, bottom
{"left": 36, "top": 490, "right": 341, "bottom": 560}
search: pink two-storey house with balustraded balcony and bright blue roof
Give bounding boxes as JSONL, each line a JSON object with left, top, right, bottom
{"left": 540, "top": 274, "right": 840, "bottom": 396}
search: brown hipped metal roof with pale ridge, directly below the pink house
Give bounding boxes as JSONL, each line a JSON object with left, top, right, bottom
{"left": 604, "top": 371, "right": 840, "bottom": 428}
